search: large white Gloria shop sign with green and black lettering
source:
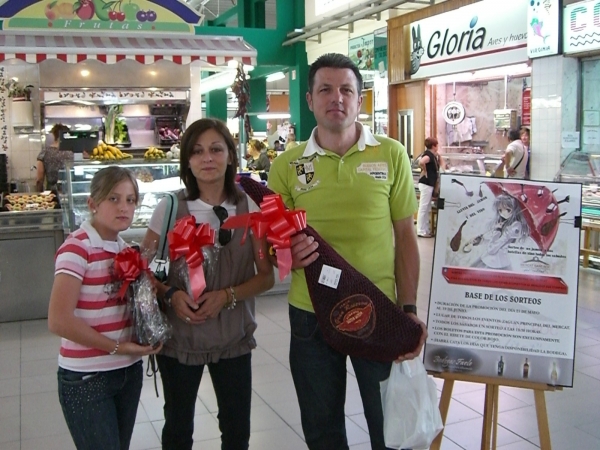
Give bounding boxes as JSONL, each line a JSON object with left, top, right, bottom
{"left": 410, "top": 0, "right": 529, "bottom": 79}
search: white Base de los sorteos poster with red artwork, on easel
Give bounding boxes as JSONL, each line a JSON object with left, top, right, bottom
{"left": 425, "top": 174, "right": 581, "bottom": 387}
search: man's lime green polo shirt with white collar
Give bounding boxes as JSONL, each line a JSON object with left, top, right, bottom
{"left": 268, "top": 124, "right": 417, "bottom": 311}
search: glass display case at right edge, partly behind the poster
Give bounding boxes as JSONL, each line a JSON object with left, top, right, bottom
{"left": 554, "top": 151, "right": 600, "bottom": 222}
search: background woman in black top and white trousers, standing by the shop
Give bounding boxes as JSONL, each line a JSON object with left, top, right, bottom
{"left": 417, "top": 137, "right": 440, "bottom": 238}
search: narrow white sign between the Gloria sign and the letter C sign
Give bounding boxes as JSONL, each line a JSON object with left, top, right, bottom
{"left": 527, "top": 0, "right": 560, "bottom": 58}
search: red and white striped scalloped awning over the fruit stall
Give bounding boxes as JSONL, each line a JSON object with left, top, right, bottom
{"left": 0, "top": 33, "right": 256, "bottom": 66}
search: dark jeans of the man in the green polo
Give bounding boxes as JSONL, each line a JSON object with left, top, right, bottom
{"left": 289, "top": 305, "right": 392, "bottom": 450}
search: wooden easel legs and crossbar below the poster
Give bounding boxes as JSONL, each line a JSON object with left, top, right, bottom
{"left": 429, "top": 372, "right": 562, "bottom": 450}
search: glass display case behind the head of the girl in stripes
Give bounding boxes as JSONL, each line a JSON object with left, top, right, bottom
{"left": 59, "top": 159, "right": 184, "bottom": 241}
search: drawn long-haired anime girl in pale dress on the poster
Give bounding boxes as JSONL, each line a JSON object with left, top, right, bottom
{"left": 472, "top": 194, "right": 529, "bottom": 270}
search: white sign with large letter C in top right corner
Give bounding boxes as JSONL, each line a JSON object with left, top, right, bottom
{"left": 563, "top": 0, "right": 600, "bottom": 53}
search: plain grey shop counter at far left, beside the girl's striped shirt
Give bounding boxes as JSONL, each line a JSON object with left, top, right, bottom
{"left": 0, "top": 209, "right": 64, "bottom": 322}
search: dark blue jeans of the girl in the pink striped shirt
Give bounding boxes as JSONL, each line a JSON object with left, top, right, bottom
{"left": 58, "top": 361, "right": 143, "bottom": 450}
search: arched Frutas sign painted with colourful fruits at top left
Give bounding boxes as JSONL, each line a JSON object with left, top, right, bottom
{"left": 0, "top": 0, "right": 202, "bottom": 34}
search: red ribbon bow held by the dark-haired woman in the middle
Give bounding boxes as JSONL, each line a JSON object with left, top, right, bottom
{"left": 167, "top": 216, "right": 215, "bottom": 300}
